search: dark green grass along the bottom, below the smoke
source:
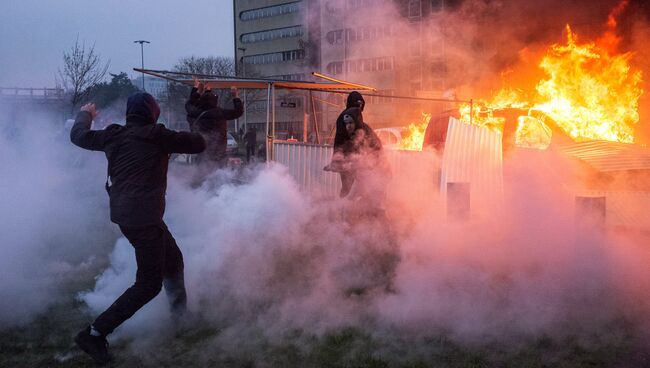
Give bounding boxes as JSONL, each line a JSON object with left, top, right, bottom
{"left": 0, "top": 280, "right": 650, "bottom": 368}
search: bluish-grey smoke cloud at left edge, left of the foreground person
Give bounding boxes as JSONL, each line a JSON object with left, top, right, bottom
{"left": 0, "top": 104, "right": 115, "bottom": 326}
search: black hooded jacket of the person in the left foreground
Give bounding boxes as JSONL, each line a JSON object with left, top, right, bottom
{"left": 70, "top": 93, "right": 205, "bottom": 226}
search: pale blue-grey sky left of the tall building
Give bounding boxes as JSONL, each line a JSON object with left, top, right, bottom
{"left": 0, "top": 0, "right": 234, "bottom": 88}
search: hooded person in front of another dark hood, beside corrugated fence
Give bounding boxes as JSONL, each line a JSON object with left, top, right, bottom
{"left": 325, "top": 107, "right": 390, "bottom": 207}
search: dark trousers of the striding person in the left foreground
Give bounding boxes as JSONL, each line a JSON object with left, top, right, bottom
{"left": 93, "top": 222, "right": 187, "bottom": 335}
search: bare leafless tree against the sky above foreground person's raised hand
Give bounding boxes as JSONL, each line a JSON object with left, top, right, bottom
{"left": 59, "top": 38, "right": 110, "bottom": 111}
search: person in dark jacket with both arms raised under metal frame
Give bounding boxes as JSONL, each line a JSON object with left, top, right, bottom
{"left": 185, "top": 82, "right": 244, "bottom": 169}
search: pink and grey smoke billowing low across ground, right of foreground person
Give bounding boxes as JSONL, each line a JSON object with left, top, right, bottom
{"left": 82, "top": 147, "right": 650, "bottom": 360}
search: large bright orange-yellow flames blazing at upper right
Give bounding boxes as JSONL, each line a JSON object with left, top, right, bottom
{"left": 460, "top": 1, "right": 643, "bottom": 148}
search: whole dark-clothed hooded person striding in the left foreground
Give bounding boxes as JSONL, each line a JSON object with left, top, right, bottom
{"left": 70, "top": 93, "right": 206, "bottom": 363}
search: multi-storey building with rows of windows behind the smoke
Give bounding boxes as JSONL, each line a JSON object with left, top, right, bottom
{"left": 234, "top": 0, "right": 456, "bottom": 142}
